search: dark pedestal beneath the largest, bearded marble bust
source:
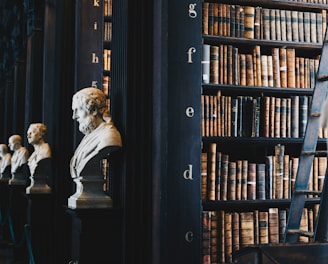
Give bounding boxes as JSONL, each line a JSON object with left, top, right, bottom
{"left": 66, "top": 208, "right": 123, "bottom": 264}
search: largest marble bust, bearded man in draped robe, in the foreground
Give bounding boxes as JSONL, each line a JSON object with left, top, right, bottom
{"left": 68, "top": 87, "right": 122, "bottom": 208}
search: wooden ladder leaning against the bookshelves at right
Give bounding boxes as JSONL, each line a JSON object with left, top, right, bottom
{"left": 284, "top": 30, "right": 328, "bottom": 243}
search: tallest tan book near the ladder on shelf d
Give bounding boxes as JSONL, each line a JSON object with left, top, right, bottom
{"left": 274, "top": 144, "right": 285, "bottom": 199}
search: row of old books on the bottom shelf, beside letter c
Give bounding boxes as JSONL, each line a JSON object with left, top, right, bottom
{"left": 202, "top": 205, "right": 318, "bottom": 264}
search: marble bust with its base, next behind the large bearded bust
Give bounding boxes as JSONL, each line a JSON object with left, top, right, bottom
{"left": 26, "top": 123, "right": 51, "bottom": 193}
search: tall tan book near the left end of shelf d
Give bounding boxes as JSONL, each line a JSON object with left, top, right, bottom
{"left": 207, "top": 143, "right": 216, "bottom": 200}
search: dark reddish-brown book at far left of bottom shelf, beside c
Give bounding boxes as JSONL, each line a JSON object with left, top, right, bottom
{"left": 202, "top": 211, "right": 211, "bottom": 264}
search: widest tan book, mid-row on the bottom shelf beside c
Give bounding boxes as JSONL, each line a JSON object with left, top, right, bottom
{"left": 239, "top": 212, "right": 254, "bottom": 248}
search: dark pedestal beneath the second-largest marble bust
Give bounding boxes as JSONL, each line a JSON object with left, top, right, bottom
{"left": 26, "top": 193, "right": 54, "bottom": 264}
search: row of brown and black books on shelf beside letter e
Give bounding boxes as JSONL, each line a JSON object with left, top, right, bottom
{"left": 201, "top": 90, "right": 328, "bottom": 138}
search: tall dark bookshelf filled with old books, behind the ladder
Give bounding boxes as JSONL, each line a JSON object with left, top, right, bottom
{"left": 201, "top": 0, "right": 328, "bottom": 263}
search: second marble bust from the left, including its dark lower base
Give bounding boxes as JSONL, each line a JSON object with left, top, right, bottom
{"left": 8, "top": 135, "right": 30, "bottom": 185}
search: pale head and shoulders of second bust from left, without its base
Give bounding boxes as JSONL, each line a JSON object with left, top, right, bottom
{"left": 8, "top": 135, "right": 30, "bottom": 173}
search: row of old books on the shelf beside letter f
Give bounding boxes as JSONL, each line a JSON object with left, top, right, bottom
{"left": 202, "top": 44, "right": 320, "bottom": 88}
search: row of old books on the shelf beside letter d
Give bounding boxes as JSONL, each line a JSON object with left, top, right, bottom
{"left": 201, "top": 143, "right": 327, "bottom": 200}
